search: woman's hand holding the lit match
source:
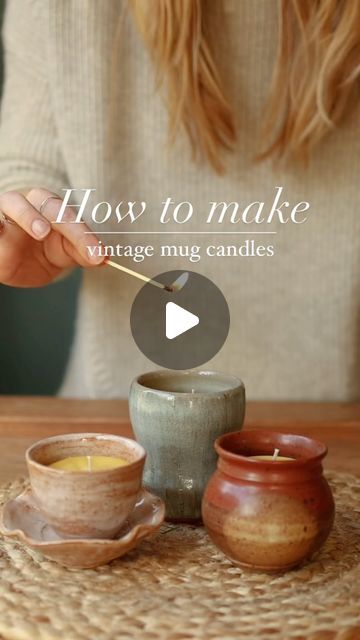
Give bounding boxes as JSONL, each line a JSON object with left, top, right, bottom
{"left": 0, "top": 189, "right": 104, "bottom": 287}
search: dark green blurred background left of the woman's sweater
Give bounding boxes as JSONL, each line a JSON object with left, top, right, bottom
{"left": 0, "top": 0, "right": 81, "bottom": 395}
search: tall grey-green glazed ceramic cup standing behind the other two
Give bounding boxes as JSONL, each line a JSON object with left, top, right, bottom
{"left": 129, "top": 370, "right": 245, "bottom": 521}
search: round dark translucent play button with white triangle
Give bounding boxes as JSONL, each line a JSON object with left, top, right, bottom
{"left": 130, "top": 271, "right": 230, "bottom": 369}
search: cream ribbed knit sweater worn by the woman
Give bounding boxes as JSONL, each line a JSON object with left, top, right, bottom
{"left": 0, "top": 0, "right": 360, "bottom": 401}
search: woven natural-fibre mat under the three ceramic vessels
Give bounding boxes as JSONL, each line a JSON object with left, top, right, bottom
{"left": 0, "top": 473, "right": 360, "bottom": 640}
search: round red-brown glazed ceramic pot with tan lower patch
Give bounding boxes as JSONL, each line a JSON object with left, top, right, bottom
{"left": 202, "top": 431, "right": 334, "bottom": 572}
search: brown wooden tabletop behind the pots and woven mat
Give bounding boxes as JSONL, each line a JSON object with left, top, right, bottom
{"left": 0, "top": 396, "right": 360, "bottom": 483}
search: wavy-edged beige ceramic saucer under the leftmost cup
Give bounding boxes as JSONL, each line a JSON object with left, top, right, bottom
{"left": 0, "top": 487, "right": 165, "bottom": 569}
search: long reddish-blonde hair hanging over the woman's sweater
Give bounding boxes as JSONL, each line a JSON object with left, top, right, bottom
{"left": 129, "top": 0, "right": 360, "bottom": 173}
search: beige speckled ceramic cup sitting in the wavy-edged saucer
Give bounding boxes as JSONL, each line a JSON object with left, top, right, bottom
{"left": 26, "top": 433, "right": 146, "bottom": 538}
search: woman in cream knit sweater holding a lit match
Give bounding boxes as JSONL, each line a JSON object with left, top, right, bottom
{"left": 0, "top": 0, "right": 360, "bottom": 401}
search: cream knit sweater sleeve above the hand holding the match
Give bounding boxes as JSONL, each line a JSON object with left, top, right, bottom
{"left": 0, "top": 0, "right": 67, "bottom": 192}
